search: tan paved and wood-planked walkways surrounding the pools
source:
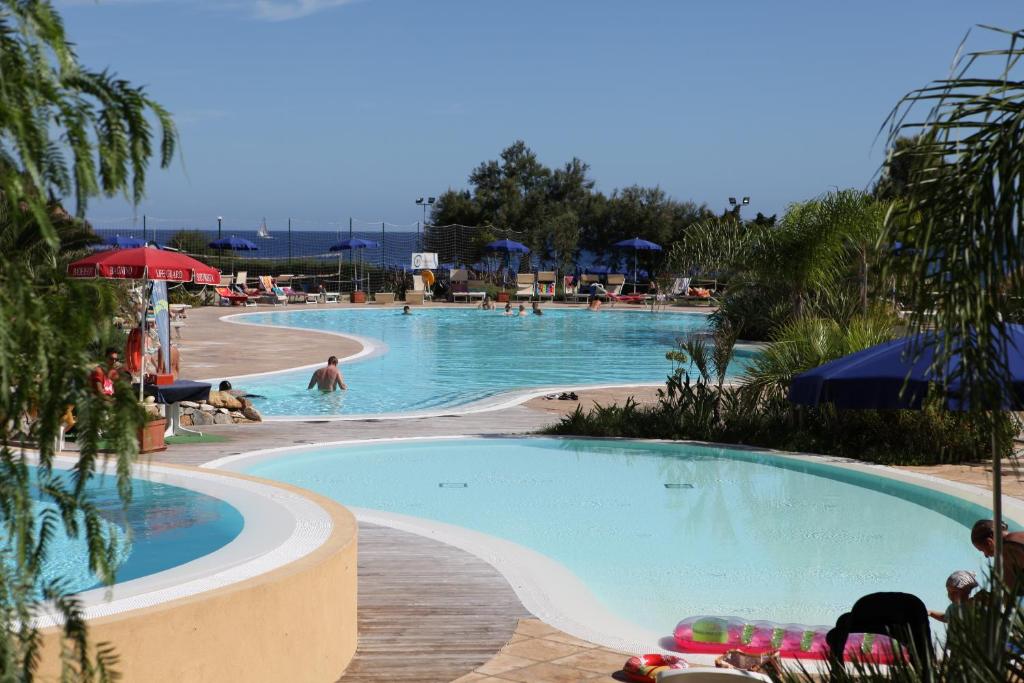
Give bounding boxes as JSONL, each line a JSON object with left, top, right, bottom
{"left": 154, "top": 304, "right": 1024, "bottom": 683}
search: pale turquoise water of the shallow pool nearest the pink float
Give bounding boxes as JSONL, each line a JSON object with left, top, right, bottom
{"left": 246, "top": 438, "right": 986, "bottom": 635}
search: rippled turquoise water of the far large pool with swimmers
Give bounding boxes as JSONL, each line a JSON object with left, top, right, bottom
{"left": 233, "top": 307, "right": 750, "bottom": 416}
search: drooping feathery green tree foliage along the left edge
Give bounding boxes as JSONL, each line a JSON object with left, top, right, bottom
{"left": 0, "top": 0, "right": 176, "bottom": 681}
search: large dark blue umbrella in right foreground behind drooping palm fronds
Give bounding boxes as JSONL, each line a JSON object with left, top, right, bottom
{"left": 790, "top": 325, "right": 1024, "bottom": 573}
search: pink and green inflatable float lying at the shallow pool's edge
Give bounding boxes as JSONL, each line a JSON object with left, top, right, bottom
{"left": 675, "top": 616, "right": 894, "bottom": 664}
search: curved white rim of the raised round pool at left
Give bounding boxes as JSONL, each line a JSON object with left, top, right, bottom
{"left": 35, "top": 456, "right": 334, "bottom": 628}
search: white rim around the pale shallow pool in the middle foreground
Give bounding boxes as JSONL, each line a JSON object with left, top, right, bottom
{"left": 202, "top": 435, "right": 1024, "bottom": 664}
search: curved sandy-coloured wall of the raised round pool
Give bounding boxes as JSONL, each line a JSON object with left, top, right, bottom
{"left": 39, "top": 473, "right": 358, "bottom": 683}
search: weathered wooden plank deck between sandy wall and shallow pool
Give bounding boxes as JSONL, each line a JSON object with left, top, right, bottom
{"left": 341, "top": 523, "right": 528, "bottom": 683}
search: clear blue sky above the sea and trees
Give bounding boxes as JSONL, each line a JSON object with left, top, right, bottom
{"left": 56, "top": 0, "right": 1024, "bottom": 228}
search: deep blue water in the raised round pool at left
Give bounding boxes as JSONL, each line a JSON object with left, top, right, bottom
{"left": 30, "top": 477, "right": 245, "bottom": 593}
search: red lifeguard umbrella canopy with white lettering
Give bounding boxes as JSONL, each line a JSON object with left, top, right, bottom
{"left": 68, "top": 247, "right": 220, "bottom": 285}
